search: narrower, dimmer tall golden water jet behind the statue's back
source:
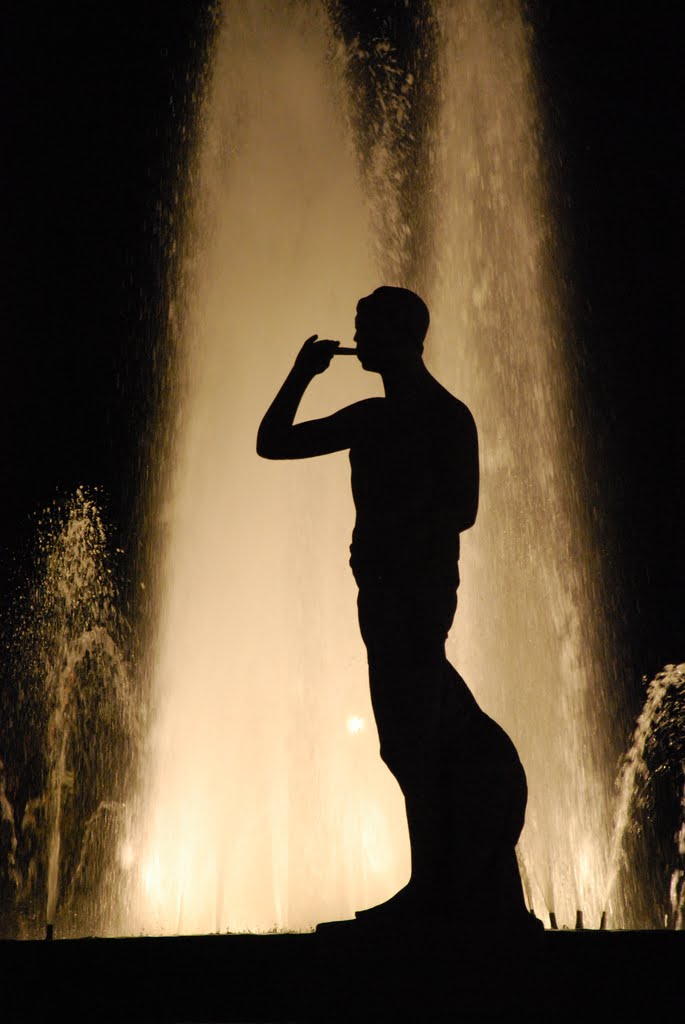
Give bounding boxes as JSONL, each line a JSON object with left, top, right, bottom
{"left": 429, "top": 0, "right": 619, "bottom": 927}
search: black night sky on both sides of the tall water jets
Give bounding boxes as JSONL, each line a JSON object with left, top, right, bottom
{"left": 0, "top": 0, "right": 685, "bottom": 692}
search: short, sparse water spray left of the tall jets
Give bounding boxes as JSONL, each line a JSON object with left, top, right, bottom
{"left": 0, "top": 490, "right": 141, "bottom": 938}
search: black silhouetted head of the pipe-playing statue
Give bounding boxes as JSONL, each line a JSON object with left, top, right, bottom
{"left": 354, "top": 286, "right": 430, "bottom": 373}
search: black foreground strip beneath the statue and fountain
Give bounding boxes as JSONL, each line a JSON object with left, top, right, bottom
{"left": 0, "top": 931, "right": 685, "bottom": 1024}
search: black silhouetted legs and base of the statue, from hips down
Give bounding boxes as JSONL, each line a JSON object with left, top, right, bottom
{"left": 352, "top": 586, "right": 527, "bottom": 937}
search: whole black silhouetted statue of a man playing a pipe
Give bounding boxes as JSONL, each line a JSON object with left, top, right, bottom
{"left": 257, "top": 288, "right": 528, "bottom": 927}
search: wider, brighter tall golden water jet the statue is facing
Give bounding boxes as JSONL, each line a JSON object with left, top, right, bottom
{"left": 133, "top": 3, "right": 409, "bottom": 932}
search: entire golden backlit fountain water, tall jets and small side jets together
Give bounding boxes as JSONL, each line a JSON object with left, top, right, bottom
{"left": 1, "top": 0, "right": 685, "bottom": 936}
